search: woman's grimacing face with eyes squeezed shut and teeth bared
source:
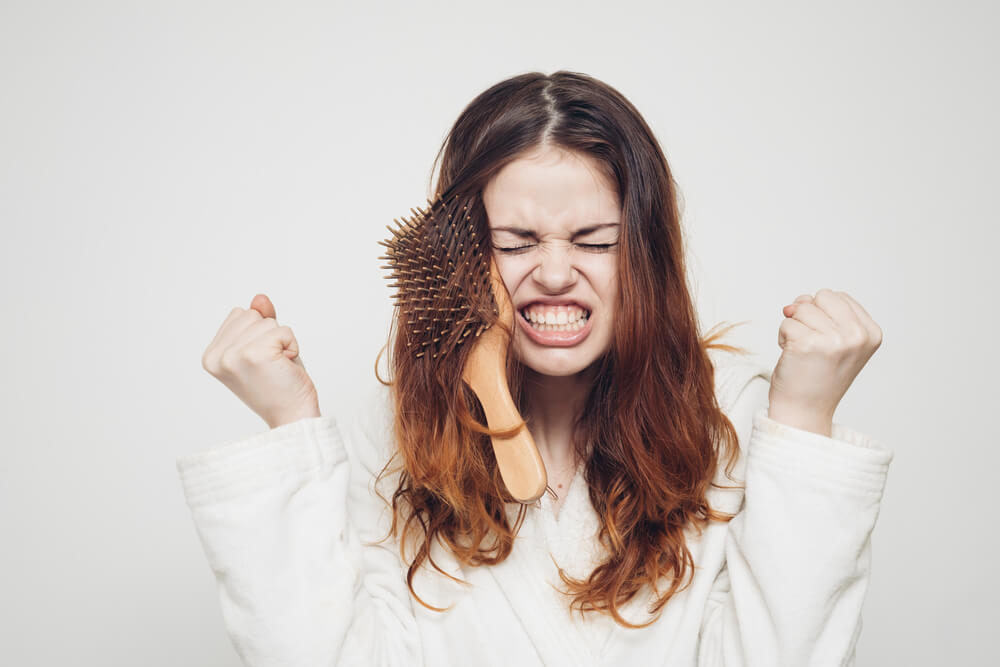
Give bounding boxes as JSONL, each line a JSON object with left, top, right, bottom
{"left": 483, "top": 146, "right": 621, "bottom": 376}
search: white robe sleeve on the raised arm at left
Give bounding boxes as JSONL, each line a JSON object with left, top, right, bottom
{"left": 177, "top": 386, "right": 423, "bottom": 667}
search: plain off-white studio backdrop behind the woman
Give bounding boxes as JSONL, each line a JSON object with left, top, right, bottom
{"left": 0, "top": 0, "right": 1000, "bottom": 667}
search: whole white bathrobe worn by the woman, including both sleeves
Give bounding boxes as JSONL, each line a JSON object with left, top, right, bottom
{"left": 177, "top": 350, "right": 893, "bottom": 667}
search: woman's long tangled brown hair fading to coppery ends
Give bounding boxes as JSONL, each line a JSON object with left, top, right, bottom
{"left": 379, "top": 71, "right": 746, "bottom": 627}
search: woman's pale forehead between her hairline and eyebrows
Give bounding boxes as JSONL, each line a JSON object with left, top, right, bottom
{"left": 483, "top": 147, "right": 621, "bottom": 233}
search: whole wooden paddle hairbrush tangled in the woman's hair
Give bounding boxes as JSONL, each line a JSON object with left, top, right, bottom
{"left": 379, "top": 193, "right": 548, "bottom": 503}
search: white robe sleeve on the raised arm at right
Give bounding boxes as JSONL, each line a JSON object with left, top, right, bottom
{"left": 698, "top": 371, "right": 893, "bottom": 667}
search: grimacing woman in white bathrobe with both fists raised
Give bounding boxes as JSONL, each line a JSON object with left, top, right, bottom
{"left": 184, "top": 72, "right": 892, "bottom": 667}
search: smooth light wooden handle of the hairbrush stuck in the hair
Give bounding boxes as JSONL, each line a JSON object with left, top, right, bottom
{"left": 462, "top": 262, "right": 548, "bottom": 503}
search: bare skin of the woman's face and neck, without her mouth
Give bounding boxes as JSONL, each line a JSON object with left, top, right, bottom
{"left": 483, "top": 146, "right": 621, "bottom": 498}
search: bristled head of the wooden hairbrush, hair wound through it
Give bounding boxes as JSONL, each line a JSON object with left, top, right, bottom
{"left": 379, "top": 193, "right": 498, "bottom": 359}
